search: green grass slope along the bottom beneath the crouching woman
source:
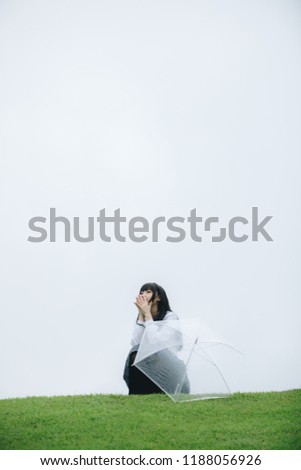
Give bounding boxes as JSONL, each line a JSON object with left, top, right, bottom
{"left": 0, "top": 390, "right": 301, "bottom": 450}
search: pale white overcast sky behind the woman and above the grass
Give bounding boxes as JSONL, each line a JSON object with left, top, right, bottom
{"left": 0, "top": 0, "right": 301, "bottom": 398}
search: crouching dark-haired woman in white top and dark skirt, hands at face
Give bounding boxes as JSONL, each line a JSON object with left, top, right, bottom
{"left": 123, "top": 282, "right": 189, "bottom": 395}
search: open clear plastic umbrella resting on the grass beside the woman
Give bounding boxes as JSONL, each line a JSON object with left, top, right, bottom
{"left": 133, "top": 320, "right": 238, "bottom": 402}
